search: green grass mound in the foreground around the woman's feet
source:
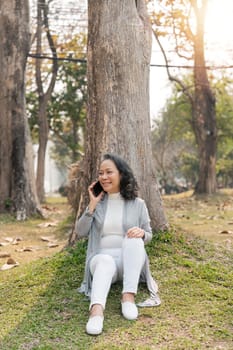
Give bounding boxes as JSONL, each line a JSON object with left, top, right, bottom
{"left": 0, "top": 232, "right": 233, "bottom": 350}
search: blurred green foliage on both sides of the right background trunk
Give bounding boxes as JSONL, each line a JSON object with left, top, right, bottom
{"left": 152, "top": 72, "right": 233, "bottom": 190}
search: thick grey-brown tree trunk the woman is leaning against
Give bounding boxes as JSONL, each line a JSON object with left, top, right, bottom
{"left": 70, "top": 0, "right": 167, "bottom": 243}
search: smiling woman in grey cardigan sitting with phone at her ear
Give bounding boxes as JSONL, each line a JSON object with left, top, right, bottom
{"left": 76, "top": 154, "right": 160, "bottom": 335}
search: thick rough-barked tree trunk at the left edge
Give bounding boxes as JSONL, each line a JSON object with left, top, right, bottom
{"left": 0, "top": 0, "right": 38, "bottom": 220}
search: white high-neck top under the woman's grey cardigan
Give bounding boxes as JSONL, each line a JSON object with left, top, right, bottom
{"left": 100, "top": 193, "right": 124, "bottom": 249}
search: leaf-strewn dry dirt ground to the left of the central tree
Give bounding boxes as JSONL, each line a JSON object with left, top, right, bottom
{"left": 0, "top": 197, "right": 71, "bottom": 269}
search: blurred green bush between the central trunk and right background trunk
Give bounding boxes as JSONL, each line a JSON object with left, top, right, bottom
{"left": 152, "top": 86, "right": 197, "bottom": 193}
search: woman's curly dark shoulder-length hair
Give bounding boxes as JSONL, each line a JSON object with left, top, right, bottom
{"left": 102, "top": 153, "right": 138, "bottom": 200}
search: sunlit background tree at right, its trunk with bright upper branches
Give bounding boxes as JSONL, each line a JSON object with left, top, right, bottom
{"left": 152, "top": 0, "right": 217, "bottom": 194}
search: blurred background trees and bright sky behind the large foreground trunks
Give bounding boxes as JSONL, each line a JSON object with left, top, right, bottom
{"left": 1, "top": 0, "right": 232, "bottom": 223}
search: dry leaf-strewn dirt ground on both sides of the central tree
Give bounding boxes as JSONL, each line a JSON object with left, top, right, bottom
{"left": 0, "top": 190, "right": 233, "bottom": 269}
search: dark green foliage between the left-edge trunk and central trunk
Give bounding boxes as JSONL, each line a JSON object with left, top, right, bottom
{"left": 27, "top": 33, "right": 87, "bottom": 169}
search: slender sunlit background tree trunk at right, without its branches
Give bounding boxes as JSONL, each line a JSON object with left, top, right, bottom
{"left": 192, "top": 0, "right": 217, "bottom": 194}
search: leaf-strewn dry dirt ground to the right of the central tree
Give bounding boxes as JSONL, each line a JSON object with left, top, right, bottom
{"left": 163, "top": 189, "right": 233, "bottom": 249}
